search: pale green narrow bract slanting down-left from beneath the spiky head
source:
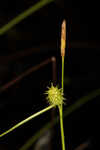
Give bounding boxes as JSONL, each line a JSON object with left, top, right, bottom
{"left": 0, "top": 105, "right": 55, "bottom": 137}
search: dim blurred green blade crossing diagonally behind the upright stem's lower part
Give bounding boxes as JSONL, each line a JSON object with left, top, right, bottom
{"left": 19, "top": 89, "right": 100, "bottom": 150}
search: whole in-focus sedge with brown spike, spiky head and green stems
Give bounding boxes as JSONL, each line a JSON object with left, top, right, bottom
{"left": 0, "top": 20, "right": 66, "bottom": 150}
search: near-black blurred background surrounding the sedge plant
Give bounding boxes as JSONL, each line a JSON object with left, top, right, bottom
{"left": 0, "top": 0, "right": 100, "bottom": 150}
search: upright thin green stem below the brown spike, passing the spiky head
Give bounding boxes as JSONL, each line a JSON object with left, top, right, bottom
{"left": 59, "top": 56, "right": 65, "bottom": 150}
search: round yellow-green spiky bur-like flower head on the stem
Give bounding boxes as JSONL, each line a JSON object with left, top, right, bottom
{"left": 45, "top": 84, "right": 65, "bottom": 106}
